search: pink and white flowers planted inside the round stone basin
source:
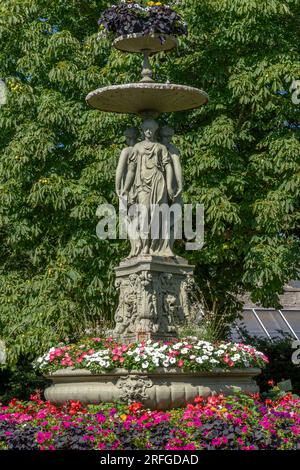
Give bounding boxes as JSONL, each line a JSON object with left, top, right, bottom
{"left": 35, "top": 338, "right": 268, "bottom": 374}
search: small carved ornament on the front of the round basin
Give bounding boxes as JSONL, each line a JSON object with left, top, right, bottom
{"left": 117, "top": 374, "right": 153, "bottom": 403}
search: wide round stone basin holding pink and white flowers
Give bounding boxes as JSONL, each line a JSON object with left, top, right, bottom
{"left": 45, "top": 368, "right": 261, "bottom": 410}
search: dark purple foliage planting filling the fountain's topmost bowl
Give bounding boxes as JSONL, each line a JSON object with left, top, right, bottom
{"left": 98, "top": 1, "right": 187, "bottom": 37}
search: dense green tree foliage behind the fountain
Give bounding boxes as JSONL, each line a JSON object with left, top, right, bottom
{"left": 0, "top": 0, "right": 300, "bottom": 363}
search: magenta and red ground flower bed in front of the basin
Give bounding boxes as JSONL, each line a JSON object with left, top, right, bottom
{"left": 0, "top": 394, "right": 300, "bottom": 450}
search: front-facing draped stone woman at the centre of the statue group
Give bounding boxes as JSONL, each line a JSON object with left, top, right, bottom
{"left": 122, "top": 119, "right": 174, "bottom": 256}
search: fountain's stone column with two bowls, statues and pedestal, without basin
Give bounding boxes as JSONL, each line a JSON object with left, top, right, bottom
{"left": 86, "top": 34, "right": 208, "bottom": 342}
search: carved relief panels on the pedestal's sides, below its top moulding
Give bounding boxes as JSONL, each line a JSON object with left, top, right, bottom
{"left": 114, "top": 264, "right": 192, "bottom": 340}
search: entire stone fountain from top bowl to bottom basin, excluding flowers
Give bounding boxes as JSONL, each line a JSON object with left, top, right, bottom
{"left": 45, "top": 34, "right": 260, "bottom": 409}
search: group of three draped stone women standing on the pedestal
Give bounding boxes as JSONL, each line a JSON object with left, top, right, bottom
{"left": 116, "top": 119, "right": 183, "bottom": 257}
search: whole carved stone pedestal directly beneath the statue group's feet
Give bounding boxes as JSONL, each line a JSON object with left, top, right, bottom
{"left": 113, "top": 255, "right": 193, "bottom": 342}
